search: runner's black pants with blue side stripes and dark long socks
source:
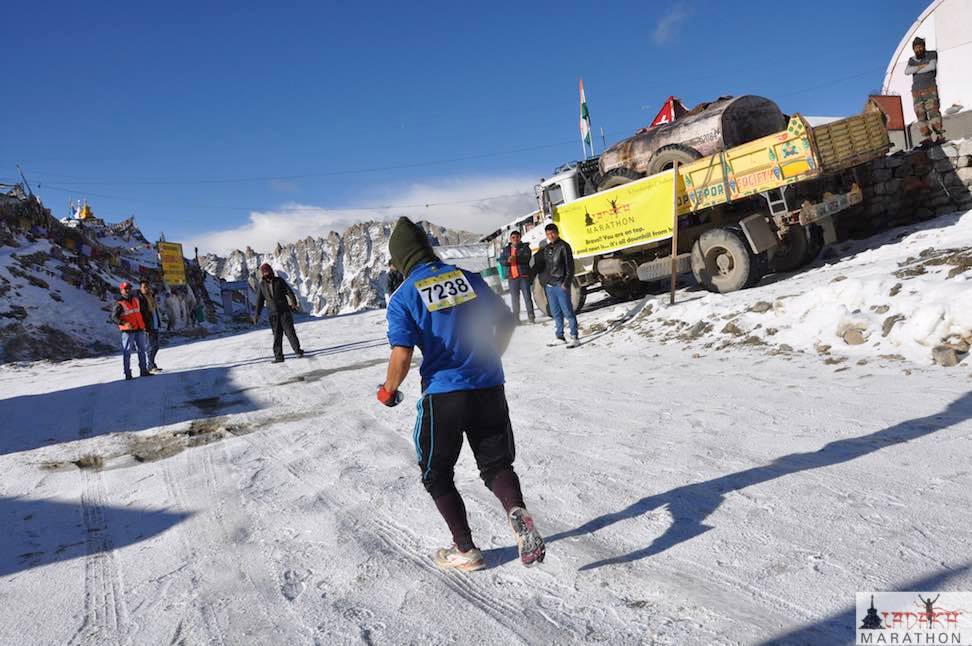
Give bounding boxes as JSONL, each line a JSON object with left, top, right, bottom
{"left": 413, "top": 386, "right": 524, "bottom": 550}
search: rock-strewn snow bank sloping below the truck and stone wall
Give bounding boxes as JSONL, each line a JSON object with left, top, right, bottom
{"left": 634, "top": 212, "right": 972, "bottom": 364}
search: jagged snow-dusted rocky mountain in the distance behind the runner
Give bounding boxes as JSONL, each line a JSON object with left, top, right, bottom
{"left": 199, "top": 222, "right": 479, "bottom": 316}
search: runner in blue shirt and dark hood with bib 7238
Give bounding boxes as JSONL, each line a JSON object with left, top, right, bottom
{"left": 378, "top": 218, "right": 545, "bottom": 571}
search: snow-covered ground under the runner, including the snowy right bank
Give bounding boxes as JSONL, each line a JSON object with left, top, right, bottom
{"left": 0, "top": 216, "right": 972, "bottom": 645}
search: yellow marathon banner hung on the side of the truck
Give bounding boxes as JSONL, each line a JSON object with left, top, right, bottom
{"left": 553, "top": 171, "right": 684, "bottom": 258}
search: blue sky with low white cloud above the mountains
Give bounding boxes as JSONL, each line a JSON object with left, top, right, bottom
{"left": 0, "top": 0, "right": 927, "bottom": 251}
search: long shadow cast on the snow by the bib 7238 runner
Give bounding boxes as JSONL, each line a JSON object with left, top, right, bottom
{"left": 487, "top": 392, "right": 972, "bottom": 570}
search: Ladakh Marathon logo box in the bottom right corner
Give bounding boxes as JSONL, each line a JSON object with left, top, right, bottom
{"left": 854, "top": 592, "right": 972, "bottom": 646}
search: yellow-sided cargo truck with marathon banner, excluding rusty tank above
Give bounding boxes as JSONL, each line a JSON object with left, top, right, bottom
{"left": 537, "top": 112, "right": 890, "bottom": 307}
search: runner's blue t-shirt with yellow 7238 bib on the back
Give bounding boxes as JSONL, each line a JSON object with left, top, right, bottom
{"left": 387, "top": 261, "right": 513, "bottom": 395}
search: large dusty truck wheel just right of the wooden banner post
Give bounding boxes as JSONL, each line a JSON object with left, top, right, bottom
{"left": 692, "top": 227, "right": 766, "bottom": 294}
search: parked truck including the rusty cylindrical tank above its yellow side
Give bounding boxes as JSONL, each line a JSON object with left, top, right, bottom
{"left": 525, "top": 96, "right": 890, "bottom": 316}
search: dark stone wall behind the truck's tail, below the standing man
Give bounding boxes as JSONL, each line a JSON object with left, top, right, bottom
{"left": 837, "top": 139, "right": 972, "bottom": 238}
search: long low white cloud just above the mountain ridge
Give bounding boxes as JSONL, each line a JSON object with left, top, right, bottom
{"left": 186, "top": 176, "right": 538, "bottom": 254}
